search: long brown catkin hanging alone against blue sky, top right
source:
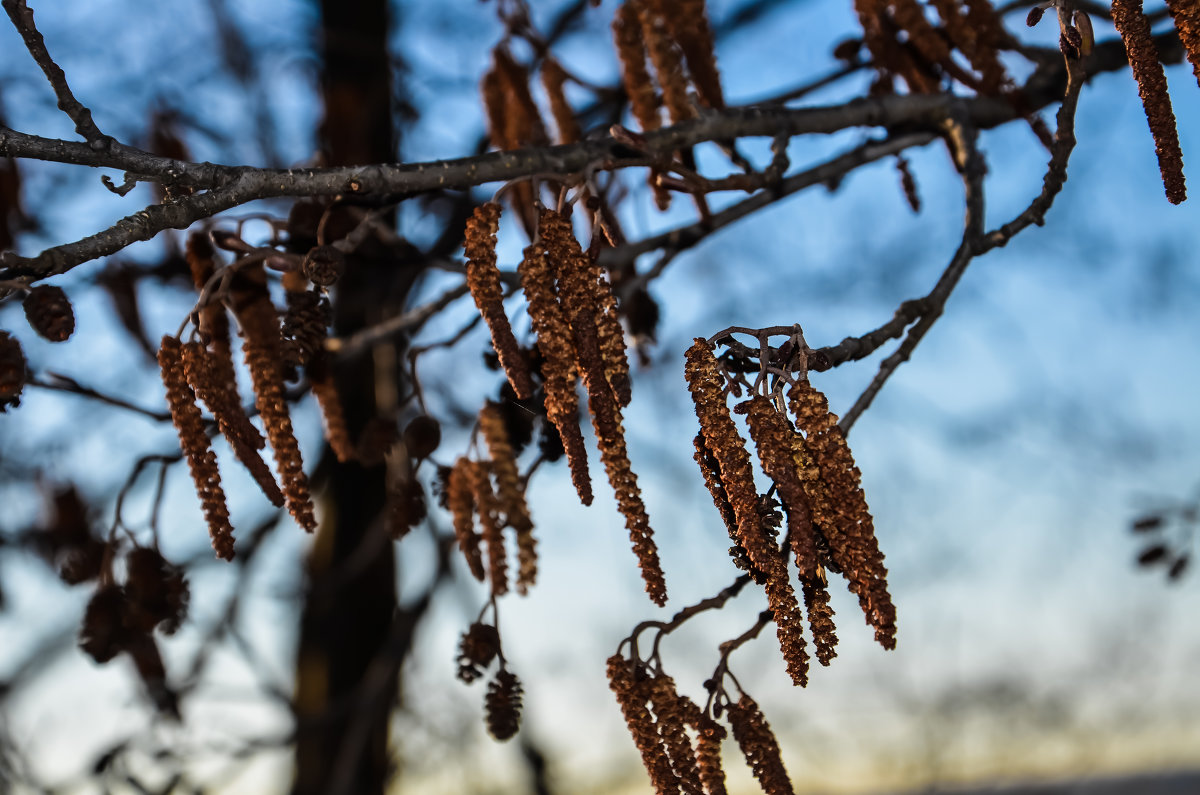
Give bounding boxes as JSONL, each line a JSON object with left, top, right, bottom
{"left": 1112, "top": 0, "right": 1187, "bottom": 204}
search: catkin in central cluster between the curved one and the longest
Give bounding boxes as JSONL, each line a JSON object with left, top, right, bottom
{"left": 517, "top": 246, "right": 592, "bottom": 506}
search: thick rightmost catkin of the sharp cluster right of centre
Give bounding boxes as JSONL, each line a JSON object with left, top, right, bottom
{"left": 787, "top": 381, "right": 896, "bottom": 648}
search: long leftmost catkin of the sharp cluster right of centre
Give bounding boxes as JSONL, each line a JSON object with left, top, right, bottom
{"left": 685, "top": 337, "right": 808, "bottom": 687}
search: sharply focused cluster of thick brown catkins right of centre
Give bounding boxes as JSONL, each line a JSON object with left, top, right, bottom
{"left": 685, "top": 339, "right": 896, "bottom": 685}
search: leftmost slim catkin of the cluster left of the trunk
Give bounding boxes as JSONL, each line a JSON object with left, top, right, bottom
{"left": 158, "top": 336, "right": 233, "bottom": 561}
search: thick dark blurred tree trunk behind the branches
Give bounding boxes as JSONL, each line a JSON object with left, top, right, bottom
{"left": 293, "top": 0, "right": 416, "bottom": 795}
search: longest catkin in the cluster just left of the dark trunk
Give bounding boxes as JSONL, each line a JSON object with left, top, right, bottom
{"left": 234, "top": 265, "right": 317, "bottom": 532}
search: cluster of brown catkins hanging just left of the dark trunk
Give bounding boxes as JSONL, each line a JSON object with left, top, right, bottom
{"left": 158, "top": 233, "right": 355, "bottom": 560}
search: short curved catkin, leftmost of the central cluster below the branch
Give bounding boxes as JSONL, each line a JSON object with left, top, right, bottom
{"left": 464, "top": 202, "right": 533, "bottom": 400}
